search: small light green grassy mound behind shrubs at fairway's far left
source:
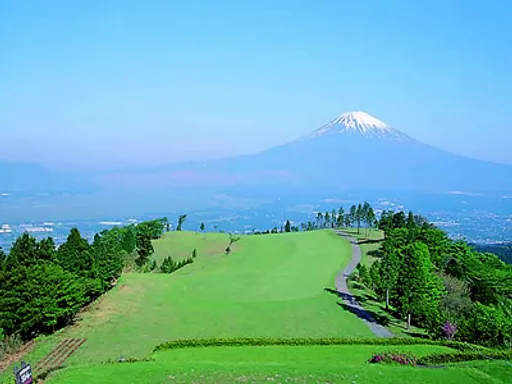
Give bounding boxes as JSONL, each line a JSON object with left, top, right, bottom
{"left": 152, "top": 232, "right": 229, "bottom": 265}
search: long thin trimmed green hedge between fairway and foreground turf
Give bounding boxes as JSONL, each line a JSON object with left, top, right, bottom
{"left": 153, "top": 337, "right": 493, "bottom": 352}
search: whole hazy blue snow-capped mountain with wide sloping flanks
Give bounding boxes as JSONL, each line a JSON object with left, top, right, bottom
{"left": 104, "top": 112, "right": 512, "bottom": 193}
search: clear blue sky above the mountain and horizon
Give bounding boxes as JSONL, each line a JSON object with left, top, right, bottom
{"left": 0, "top": 0, "right": 512, "bottom": 168}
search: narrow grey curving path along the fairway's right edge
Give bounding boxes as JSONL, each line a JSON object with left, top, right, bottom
{"left": 335, "top": 231, "right": 394, "bottom": 337}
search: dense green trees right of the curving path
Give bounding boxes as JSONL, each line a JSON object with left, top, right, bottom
{"left": 359, "top": 211, "right": 512, "bottom": 347}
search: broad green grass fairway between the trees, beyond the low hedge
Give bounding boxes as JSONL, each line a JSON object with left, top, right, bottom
{"left": 20, "top": 231, "right": 373, "bottom": 365}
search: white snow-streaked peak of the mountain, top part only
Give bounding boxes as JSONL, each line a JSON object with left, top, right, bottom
{"left": 310, "top": 111, "right": 408, "bottom": 141}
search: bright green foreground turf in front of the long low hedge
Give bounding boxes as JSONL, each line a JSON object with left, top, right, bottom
{"left": 49, "top": 345, "right": 512, "bottom": 384}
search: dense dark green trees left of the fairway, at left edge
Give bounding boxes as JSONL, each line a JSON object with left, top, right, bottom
{"left": 0, "top": 219, "right": 167, "bottom": 340}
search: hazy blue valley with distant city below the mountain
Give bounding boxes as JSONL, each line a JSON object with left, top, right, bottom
{"left": 0, "top": 188, "right": 512, "bottom": 254}
